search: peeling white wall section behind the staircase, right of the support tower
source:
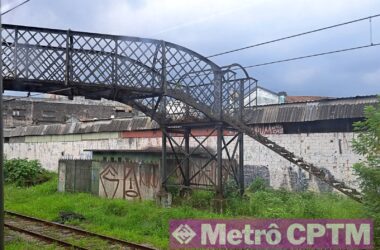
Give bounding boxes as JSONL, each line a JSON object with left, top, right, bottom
{"left": 244, "top": 133, "right": 361, "bottom": 191}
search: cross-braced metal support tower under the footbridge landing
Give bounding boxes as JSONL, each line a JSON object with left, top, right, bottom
{"left": 161, "top": 126, "right": 244, "bottom": 197}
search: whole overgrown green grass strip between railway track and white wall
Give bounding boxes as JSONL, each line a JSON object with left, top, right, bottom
{"left": 5, "top": 177, "right": 364, "bottom": 249}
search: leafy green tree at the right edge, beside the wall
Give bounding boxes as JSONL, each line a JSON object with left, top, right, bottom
{"left": 353, "top": 98, "right": 380, "bottom": 246}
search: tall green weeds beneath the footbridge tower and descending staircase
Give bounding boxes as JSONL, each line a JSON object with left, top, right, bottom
{"left": 175, "top": 179, "right": 365, "bottom": 219}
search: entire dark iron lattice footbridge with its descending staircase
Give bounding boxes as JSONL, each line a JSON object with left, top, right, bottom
{"left": 1, "top": 25, "right": 360, "bottom": 199}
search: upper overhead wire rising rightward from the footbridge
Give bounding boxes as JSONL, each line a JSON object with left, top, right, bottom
{"left": 207, "top": 14, "right": 380, "bottom": 58}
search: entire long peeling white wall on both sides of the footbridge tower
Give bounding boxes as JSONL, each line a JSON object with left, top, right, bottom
{"left": 4, "top": 132, "right": 360, "bottom": 191}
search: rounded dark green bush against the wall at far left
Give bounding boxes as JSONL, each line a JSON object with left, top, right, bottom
{"left": 4, "top": 159, "right": 51, "bottom": 187}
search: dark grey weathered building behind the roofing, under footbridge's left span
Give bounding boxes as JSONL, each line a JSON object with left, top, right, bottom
{"left": 3, "top": 96, "right": 136, "bottom": 128}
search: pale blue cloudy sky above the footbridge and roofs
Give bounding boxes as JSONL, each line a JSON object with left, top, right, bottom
{"left": 2, "top": 0, "right": 380, "bottom": 97}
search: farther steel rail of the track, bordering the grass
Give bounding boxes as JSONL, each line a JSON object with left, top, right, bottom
{"left": 4, "top": 211, "right": 155, "bottom": 250}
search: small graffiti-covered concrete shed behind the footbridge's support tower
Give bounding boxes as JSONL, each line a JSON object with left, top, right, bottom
{"left": 58, "top": 148, "right": 226, "bottom": 200}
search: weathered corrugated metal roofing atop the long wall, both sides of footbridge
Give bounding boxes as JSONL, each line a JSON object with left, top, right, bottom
{"left": 4, "top": 96, "right": 378, "bottom": 137}
